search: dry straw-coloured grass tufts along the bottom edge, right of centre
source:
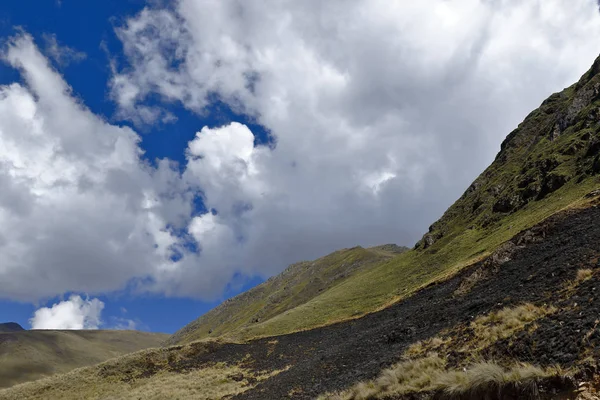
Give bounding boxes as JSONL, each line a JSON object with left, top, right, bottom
{"left": 319, "top": 355, "right": 564, "bottom": 400}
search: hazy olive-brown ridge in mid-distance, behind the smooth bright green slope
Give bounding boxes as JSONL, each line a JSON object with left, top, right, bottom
{"left": 167, "top": 244, "right": 408, "bottom": 344}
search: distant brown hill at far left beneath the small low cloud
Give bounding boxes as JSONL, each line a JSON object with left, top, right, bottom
{"left": 0, "top": 330, "right": 168, "bottom": 388}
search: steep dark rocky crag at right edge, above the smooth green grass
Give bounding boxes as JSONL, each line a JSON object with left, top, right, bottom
{"left": 416, "top": 54, "right": 600, "bottom": 249}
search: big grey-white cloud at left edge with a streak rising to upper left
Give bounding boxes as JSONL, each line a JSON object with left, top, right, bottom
{"left": 0, "top": 35, "right": 191, "bottom": 300}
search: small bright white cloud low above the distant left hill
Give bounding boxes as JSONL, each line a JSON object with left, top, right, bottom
{"left": 29, "top": 295, "right": 105, "bottom": 329}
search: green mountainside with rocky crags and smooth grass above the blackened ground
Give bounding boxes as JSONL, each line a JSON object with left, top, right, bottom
{"left": 174, "top": 52, "right": 600, "bottom": 341}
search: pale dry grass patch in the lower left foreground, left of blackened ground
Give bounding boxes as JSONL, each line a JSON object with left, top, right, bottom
{"left": 0, "top": 342, "right": 288, "bottom": 400}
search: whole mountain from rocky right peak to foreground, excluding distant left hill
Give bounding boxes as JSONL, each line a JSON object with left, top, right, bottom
{"left": 0, "top": 58, "right": 600, "bottom": 400}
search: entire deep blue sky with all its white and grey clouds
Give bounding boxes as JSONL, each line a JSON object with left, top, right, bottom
{"left": 0, "top": 0, "right": 600, "bottom": 332}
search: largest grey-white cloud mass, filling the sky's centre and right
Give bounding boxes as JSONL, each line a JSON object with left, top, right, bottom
{"left": 111, "top": 0, "right": 600, "bottom": 295}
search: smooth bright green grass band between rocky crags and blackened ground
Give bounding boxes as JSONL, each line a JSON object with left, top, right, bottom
{"left": 228, "top": 178, "right": 600, "bottom": 339}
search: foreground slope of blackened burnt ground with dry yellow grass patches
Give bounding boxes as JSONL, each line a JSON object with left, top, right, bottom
{"left": 0, "top": 203, "right": 600, "bottom": 400}
